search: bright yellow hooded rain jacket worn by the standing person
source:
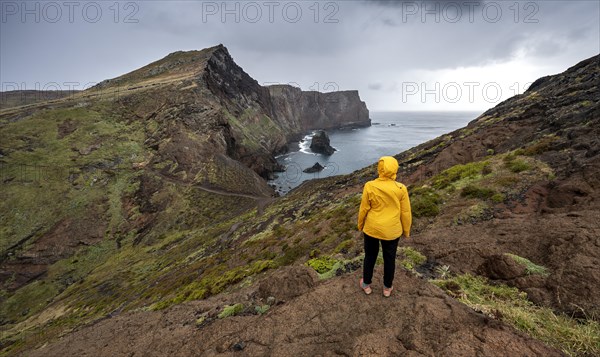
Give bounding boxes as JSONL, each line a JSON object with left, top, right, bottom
{"left": 358, "top": 156, "right": 412, "bottom": 240}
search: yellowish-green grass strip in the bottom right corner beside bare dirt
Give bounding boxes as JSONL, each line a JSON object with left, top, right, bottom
{"left": 431, "top": 274, "right": 600, "bottom": 356}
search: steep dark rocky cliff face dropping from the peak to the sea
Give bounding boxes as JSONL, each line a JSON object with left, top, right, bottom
{"left": 202, "top": 46, "right": 371, "bottom": 177}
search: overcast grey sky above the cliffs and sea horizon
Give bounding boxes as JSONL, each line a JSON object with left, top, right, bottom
{"left": 0, "top": 0, "right": 600, "bottom": 111}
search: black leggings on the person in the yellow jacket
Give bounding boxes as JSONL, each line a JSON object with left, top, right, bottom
{"left": 363, "top": 233, "right": 400, "bottom": 288}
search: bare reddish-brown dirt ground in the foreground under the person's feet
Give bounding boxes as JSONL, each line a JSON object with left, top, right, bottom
{"left": 27, "top": 266, "right": 562, "bottom": 357}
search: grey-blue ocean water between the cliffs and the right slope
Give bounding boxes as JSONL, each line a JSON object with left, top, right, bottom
{"left": 269, "top": 111, "right": 481, "bottom": 195}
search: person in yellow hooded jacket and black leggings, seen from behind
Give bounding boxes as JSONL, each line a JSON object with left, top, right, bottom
{"left": 358, "top": 156, "right": 412, "bottom": 297}
